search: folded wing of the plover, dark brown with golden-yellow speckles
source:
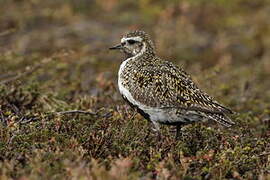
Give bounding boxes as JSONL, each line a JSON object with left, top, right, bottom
{"left": 134, "top": 61, "right": 232, "bottom": 115}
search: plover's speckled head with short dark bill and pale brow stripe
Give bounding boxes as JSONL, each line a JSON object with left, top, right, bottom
{"left": 110, "top": 30, "right": 155, "bottom": 57}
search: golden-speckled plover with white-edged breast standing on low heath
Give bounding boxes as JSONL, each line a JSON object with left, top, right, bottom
{"left": 109, "top": 30, "right": 235, "bottom": 139}
